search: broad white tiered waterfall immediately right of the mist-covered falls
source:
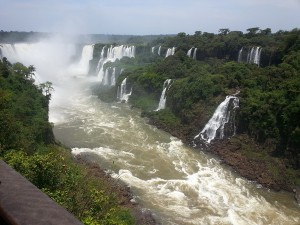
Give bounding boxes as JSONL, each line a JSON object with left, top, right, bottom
{"left": 97, "top": 45, "right": 135, "bottom": 86}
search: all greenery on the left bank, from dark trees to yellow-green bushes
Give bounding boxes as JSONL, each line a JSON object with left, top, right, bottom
{"left": 0, "top": 58, "right": 135, "bottom": 225}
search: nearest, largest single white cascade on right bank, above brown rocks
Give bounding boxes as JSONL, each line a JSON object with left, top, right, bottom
{"left": 194, "top": 95, "right": 239, "bottom": 143}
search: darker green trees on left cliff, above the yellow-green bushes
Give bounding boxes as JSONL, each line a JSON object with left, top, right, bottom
{"left": 0, "top": 59, "right": 54, "bottom": 152}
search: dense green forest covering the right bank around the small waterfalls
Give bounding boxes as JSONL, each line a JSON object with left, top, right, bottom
{"left": 98, "top": 28, "right": 300, "bottom": 189}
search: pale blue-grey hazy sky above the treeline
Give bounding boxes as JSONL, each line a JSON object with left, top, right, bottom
{"left": 0, "top": 0, "right": 300, "bottom": 35}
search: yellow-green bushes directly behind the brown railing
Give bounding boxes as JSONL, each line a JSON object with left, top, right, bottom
{"left": 3, "top": 149, "right": 134, "bottom": 225}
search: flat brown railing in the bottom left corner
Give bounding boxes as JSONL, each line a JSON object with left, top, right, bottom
{"left": 0, "top": 160, "right": 82, "bottom": 225}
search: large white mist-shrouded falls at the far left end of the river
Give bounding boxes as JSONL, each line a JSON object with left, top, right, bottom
{"left": 0, "top": 41, "right": 94, "bottom": 82}
